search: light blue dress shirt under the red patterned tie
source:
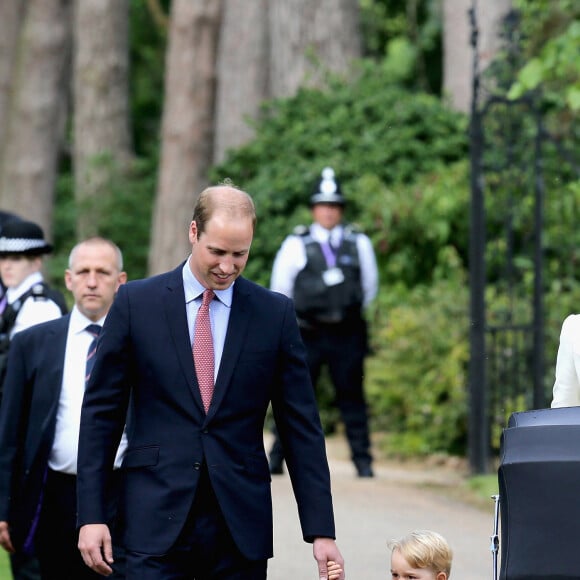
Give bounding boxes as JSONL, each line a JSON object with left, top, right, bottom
{"left": 183, "top": 259, "right": 235, "bottom": 382}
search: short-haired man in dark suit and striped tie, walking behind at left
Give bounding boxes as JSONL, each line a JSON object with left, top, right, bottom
{"left": 0, "top": 238, "right": 126, "bottom": 580}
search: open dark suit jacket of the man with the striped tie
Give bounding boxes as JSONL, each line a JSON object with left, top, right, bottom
{"left": 0, "top": 315, "right": 70, "bottom": 550}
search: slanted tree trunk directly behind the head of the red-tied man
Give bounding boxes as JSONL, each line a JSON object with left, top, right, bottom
{"left": 149, "top": 0, "right": 223, "bottom": 274}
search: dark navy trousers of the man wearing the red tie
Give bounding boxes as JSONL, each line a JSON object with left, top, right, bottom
{"left": 127, "top": 464, "right": 268, "bottom": 580}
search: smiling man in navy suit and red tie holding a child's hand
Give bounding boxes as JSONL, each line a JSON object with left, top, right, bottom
{"left": 78, "top": 185, "right": 344, "bottom": 580}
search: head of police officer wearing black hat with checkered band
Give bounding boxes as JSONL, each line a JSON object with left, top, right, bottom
{"left": 0, "top": 220, "right": 52, "bottom": 288}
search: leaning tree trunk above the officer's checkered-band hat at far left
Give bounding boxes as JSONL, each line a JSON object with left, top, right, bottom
{"left": 0, "top": 0, "right": 72, "bottom": 236}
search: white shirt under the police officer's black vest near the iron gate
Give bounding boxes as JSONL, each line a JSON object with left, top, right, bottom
{"left": 270, "top": 223, "right": 379, "bottom": 307}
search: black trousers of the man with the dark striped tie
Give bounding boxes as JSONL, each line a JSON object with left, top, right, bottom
{"left": 35, "top": 469, "right": 125, "bottom": 580}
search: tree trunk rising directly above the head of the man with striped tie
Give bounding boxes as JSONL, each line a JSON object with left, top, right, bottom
{"left": 74, "top": 0, "right": 131, "bottom": 238}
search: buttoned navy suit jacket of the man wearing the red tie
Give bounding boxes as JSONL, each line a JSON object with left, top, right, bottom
{"left": 78, "top": 266, "right": 335, "bottom": 559}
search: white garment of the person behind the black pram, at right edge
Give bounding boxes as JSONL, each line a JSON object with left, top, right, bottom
{"left": 552, "top": 314, "right": 580, "bottom": 407}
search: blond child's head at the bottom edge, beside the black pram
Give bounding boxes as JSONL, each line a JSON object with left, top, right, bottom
{"left": 389, "top": 530, "right": 453, "bottom": 580}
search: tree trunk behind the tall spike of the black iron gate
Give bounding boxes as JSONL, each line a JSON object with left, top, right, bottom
{"left": 443, "top": 0, "right": 511, "bottom": 112}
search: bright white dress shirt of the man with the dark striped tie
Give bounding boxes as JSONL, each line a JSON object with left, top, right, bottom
{"left": 48, "top": 306, "right": 127, "bottom": 475}
